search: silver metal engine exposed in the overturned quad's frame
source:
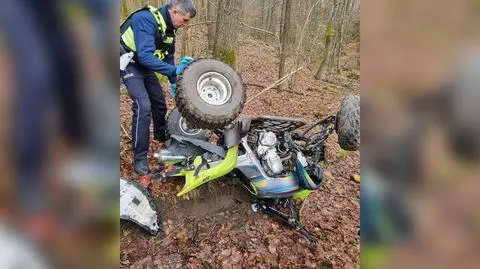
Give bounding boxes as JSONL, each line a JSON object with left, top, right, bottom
{"left": 257, "top": 132, "right": 283, "bottom": 175}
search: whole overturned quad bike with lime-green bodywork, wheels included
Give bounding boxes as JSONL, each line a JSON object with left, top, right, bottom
{"left": 120, "top": 60, "right": 360, "bottom": 247}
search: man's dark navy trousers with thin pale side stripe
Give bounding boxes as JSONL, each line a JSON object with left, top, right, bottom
{"left": 121, "top": 63, "right": 167, "bottom": 161}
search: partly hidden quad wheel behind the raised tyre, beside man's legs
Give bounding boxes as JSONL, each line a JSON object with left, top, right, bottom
{"left": 167, "top": 108, "right": 211, "bottom": 141}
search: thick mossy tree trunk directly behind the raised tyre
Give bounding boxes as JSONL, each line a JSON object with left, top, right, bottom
{"left": 213, "top": 0, "right": 242, "bottom": 68}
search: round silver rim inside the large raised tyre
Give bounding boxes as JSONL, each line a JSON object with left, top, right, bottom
{"left": 197, "top": 72, "right": 232, "bottom": 106}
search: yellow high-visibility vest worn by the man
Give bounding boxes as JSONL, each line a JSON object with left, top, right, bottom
{"left": 120, "top": 5, "right": 176, "bottom": 60}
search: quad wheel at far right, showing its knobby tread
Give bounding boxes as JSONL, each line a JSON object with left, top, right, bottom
{"left": 335, "top": 95, "right": 360, "bottom": 151}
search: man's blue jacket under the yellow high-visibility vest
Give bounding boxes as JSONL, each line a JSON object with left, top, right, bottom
{"left": 130, "top": 6, "right": 176, "bottom": 79}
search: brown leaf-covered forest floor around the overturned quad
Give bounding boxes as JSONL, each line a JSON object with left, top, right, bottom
{"left": 120, "top": 26, "right": 360, "bottom": 268}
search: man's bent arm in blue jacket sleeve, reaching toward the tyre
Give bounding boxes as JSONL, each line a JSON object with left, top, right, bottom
{"left": 132, "top": 12, "right": 176, "bottom": 78}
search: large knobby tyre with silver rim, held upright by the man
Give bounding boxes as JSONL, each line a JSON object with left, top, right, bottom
{"left": 175, "top": 59, "right": 246, "bottom": 130}
